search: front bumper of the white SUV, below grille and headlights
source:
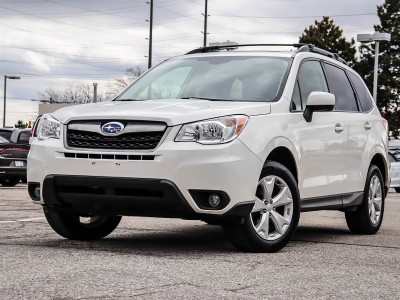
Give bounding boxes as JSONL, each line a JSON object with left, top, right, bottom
{"left": 28, "top": 127, "right": 263, "bottom": 218}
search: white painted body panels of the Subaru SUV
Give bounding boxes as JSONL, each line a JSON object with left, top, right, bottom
{"left": 28, "top": 52, "right": 389, "bottom": 215}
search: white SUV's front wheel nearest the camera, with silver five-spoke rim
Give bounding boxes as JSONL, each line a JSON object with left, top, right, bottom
{"left": 223, "top": 161, "right": 300, "bottom": 252}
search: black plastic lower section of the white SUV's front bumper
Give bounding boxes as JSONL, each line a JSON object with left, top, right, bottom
{"left": 34, "top": 175, "right": 254, "bottom": 219}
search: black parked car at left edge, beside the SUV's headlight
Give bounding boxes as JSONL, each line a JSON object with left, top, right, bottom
{"left": 0, "top": 134, "right": 30, "bottom": 186}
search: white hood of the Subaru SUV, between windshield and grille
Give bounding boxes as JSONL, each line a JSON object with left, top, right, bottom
{"left": 52, "top": 99, "right": 271, "bottom": 126}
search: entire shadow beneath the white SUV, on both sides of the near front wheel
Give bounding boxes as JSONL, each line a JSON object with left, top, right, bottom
{"left": 35, "top": 224, "right": 351, "bottom": 257}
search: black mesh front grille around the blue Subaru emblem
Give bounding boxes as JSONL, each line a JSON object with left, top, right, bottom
{"left": 67, "top": 121, "right": 166, "bottom": 150}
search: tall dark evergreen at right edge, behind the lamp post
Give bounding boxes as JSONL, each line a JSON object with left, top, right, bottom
{"left": 355, "top": 0, "right": 400, "bottom": 138}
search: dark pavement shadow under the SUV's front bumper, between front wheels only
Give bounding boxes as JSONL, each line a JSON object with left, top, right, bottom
{"left": 39, "top": 224, "right": 238, "bottom": 256}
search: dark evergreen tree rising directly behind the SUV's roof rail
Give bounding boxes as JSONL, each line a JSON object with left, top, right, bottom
{"left": 299, "top": 17, "right": 356, "bottom": 66}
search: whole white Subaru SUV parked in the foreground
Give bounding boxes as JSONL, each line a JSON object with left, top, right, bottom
{"left": 28, "top": 44, "right": 389, "bottom": 252}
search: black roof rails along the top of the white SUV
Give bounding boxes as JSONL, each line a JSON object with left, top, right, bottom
{"left": 186, "top": 43, "right": 347, "bottom": 65}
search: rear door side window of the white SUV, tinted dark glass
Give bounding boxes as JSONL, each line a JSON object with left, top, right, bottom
{"left": 325, "top": 64, "right": 358, "bottom": 111}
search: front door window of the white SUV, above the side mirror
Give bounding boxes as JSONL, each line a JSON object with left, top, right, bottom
{"left": 298, "top": 60, "right": 328, "bottom": 108}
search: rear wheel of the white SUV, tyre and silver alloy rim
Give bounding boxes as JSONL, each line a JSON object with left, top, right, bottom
{"left": 345, "top": 165, "right": 385, "bottom": 234}
